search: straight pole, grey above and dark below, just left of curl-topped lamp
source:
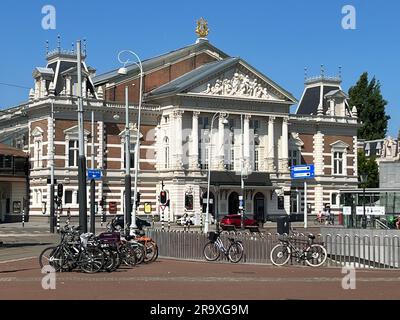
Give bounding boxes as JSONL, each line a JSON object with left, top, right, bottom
{"left": 124, "top": 86, "right": 132, "bottom": 234}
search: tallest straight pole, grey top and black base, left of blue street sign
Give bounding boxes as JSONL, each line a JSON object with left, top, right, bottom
{"left": 76, "top": 41, "right": 87, "bottom": 233}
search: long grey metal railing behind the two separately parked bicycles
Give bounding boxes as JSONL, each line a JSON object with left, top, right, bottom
{"left": 147, "top": 229, "right": 400, "bottom": 269}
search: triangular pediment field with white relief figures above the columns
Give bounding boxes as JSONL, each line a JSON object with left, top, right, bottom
{"left": 188, "top": 62, "right": 291, "bottom": 101}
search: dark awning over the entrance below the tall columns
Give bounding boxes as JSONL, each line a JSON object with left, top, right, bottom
{"left": 210, "top": 171, "right": 272, "bottom": 187}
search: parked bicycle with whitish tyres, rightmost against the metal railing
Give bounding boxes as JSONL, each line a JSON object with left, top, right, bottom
{"left": 270, "top": 234, "right": 328, "bottom": 267}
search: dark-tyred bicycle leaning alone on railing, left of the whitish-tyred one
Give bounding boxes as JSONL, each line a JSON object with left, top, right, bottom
{"left": 203, "top": 232, "right": 244, "bottom": 263}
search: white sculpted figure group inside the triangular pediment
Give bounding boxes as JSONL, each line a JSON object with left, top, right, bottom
{"left": 202, "top": 73, "right": 270, "bottom": 99}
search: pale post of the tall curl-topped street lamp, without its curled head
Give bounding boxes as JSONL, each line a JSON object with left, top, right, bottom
{"left": 131, "top": 63, "right": 143, "bottom": 234}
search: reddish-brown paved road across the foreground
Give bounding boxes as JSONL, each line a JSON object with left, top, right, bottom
{"left": 0, "top": 258, "right": 400, "bottom": 300}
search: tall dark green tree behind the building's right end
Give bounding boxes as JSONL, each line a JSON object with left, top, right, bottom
{"left": 349, "top": 72, "right": 390, "bottom": 140}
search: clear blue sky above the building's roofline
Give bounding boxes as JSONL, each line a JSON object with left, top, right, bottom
{"left": 0, "top": 0, "right": 400, "bottom": 136}
